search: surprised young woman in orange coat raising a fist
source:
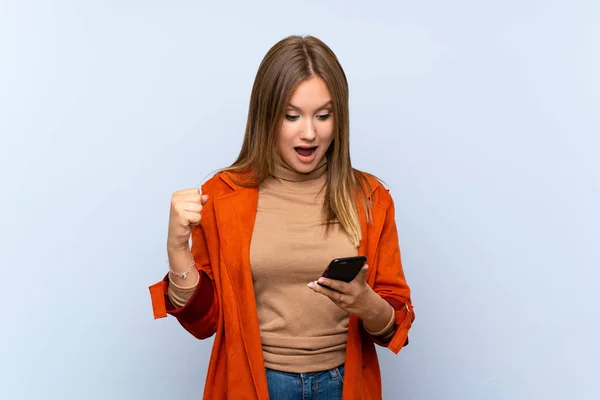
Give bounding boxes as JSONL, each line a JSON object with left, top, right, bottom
{"left": 150, "top": 36, "right": 414, "bottom": 400}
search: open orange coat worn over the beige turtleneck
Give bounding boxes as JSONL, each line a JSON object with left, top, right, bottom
{"left": 150, "top": 173, "right": 414, "bottom": 400}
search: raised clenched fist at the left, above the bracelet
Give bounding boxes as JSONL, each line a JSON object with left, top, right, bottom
{"left": 167, "top": 188, "right": 208, "bottom": 250}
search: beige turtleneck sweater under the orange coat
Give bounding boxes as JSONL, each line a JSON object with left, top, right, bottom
{"left": 169, "top": 162, "right": 358, "bottom": 373}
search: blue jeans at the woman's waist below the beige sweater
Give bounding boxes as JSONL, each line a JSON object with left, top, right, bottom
{"left": 266, "top": 365, "right": 344, "bottom": 400}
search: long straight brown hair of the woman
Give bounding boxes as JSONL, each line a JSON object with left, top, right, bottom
{"left": 223, "top": 35, "right": 371, "bottom": 246}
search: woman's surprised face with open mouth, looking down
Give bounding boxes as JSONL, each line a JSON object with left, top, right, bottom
{"left": 277, "top": 76, "right": 334, "bottom": 173}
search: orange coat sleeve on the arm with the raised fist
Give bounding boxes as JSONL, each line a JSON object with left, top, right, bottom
{"left": 150, "top": 192, "right": 219, "bottom": 339}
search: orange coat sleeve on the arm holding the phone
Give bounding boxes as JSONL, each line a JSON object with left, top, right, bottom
{"left": 370, "top": 197, "right": 415, "bottom": 353}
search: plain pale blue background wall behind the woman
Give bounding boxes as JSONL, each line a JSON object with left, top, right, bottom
{"left": 0, "top": 0, "right": 600, "bottom": 400}
